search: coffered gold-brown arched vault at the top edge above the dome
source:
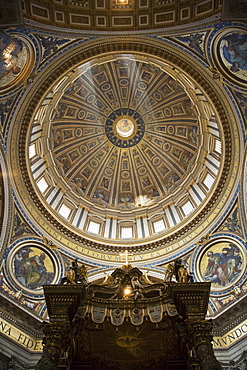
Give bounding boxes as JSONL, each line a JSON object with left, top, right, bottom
{"left": 22, "top": 0, "right": 222, "bottom": 32}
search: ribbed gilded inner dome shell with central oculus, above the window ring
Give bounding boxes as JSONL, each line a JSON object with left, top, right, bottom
{"left": 38, "top": 54, "right": 214, "bottom": 215}
